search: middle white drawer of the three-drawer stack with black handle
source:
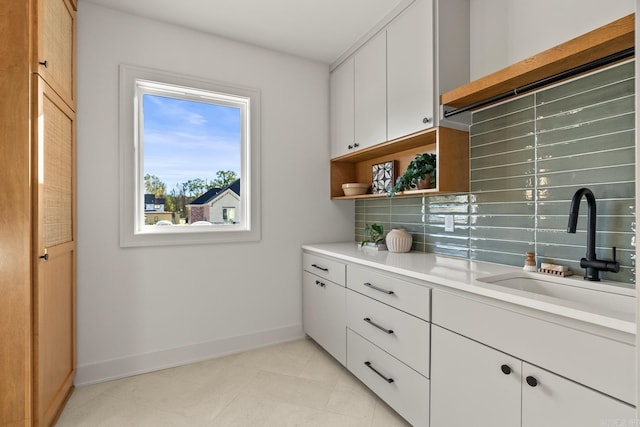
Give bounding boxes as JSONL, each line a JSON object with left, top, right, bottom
{"left": 347, "top": 290, "right": 430, "bottom": 377}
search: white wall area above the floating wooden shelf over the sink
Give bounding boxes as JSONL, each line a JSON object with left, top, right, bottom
{"left": 471, "top": 0, "right": 635, "bottom": 80}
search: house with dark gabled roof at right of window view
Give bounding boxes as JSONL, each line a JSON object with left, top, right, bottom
{"left": 187, "top": 179, "right": 240, "bottom": 224}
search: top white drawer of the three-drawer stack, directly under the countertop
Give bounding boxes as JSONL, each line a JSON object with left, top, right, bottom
{"left": 347, "top": 265, "right": 431, "bottom": 320}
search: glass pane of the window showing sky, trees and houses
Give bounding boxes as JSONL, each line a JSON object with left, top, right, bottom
{"left": 142, "top": 93, "right": 242, "bottom": 225}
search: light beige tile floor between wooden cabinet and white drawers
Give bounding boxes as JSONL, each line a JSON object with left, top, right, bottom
{"left": 56, "top": 339, "right": 409, "bottom": 427}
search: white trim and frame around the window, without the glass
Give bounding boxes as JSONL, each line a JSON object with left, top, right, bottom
{"left": 120, "top": 64, "right": 261, "bottom": 247}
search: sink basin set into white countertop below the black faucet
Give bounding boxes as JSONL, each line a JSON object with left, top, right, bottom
{"left": 477, "top": 271, "right": 636, "bottom": 322}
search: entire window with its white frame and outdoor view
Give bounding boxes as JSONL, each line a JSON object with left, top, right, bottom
{"left": 120, "top": 65, "right": 260, "bottom": 246}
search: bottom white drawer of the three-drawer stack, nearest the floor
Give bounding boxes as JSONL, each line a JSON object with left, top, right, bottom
{"left": 347, "top": 329, "right": 429, "bottom": 426}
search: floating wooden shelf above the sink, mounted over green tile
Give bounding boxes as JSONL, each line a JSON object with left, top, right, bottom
{"left": 440, "top": 14, "right": 635, "bottom": 108}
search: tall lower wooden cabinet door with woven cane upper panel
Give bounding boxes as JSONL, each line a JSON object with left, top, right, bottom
{"left": 34, "top": 77, "right": 76, "bottom": 425}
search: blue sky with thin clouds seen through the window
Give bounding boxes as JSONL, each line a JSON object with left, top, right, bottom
{"left": 143, "top": 94, "right": 241, "bottom": 193}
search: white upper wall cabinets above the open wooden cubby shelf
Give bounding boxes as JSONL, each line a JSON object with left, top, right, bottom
{"left": 331, "top": 0, "right": 470, "bottom": 158}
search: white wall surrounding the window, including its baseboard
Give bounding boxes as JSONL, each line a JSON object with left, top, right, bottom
{"left": 76, "top": 2, "right": 353, "bottom": 384}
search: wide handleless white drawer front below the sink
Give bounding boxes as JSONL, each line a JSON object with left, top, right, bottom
{"left": 433, "top": 290, "right": 635, "bottom": 404}
